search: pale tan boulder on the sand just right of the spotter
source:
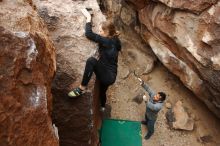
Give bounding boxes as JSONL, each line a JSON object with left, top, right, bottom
{"left": 172, "top": 101, "right": 194, "bottom": 130}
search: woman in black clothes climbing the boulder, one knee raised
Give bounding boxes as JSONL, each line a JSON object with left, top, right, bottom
{"left": 68, "top": 9, "right": 121, "bottom": 111}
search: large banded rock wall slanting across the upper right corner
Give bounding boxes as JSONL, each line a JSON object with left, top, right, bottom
{"left": 119, "top": 0, "right": 220, "bottom": 117}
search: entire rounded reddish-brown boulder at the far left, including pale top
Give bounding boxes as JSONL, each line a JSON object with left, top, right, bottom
{"left": 0, "top": 0, "right": 59, "bottom": 146}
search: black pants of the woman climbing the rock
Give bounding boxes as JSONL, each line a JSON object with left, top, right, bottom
{"left": 81, "top": 57, "right": 117, "bottom": 107}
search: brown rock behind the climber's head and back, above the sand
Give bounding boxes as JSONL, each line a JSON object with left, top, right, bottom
{"left": 97, "top": 0, "right": 156, "bottom": 75}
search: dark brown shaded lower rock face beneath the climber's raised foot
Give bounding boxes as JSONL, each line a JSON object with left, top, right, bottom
{"left": 52, "top": 68, "right": 92, "bottom": 146}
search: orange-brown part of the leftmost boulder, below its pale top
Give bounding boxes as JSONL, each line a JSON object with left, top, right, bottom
{"left": 0, "top": 27, "right": 58, "bottom": 146}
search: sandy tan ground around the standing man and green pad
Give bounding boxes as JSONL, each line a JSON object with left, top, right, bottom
{"left": 107, "top": 49, "right": 220, "bottom": 146}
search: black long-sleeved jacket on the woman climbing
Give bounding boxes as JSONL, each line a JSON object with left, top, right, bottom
{"left": 85, "top": 22, "right": 121, "bottom": 74}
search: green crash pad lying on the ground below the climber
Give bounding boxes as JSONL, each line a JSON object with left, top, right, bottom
{"left": 100, "top": 119, "right": 142, "bottom": 146}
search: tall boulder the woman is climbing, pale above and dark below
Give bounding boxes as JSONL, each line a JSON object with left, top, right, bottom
{"left": 34, "top": 0, "right": 105, "bottom": 146}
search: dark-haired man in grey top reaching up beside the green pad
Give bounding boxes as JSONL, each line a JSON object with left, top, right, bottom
{"left": 140, "top": 80, "right": 166, "bottom": 140}
